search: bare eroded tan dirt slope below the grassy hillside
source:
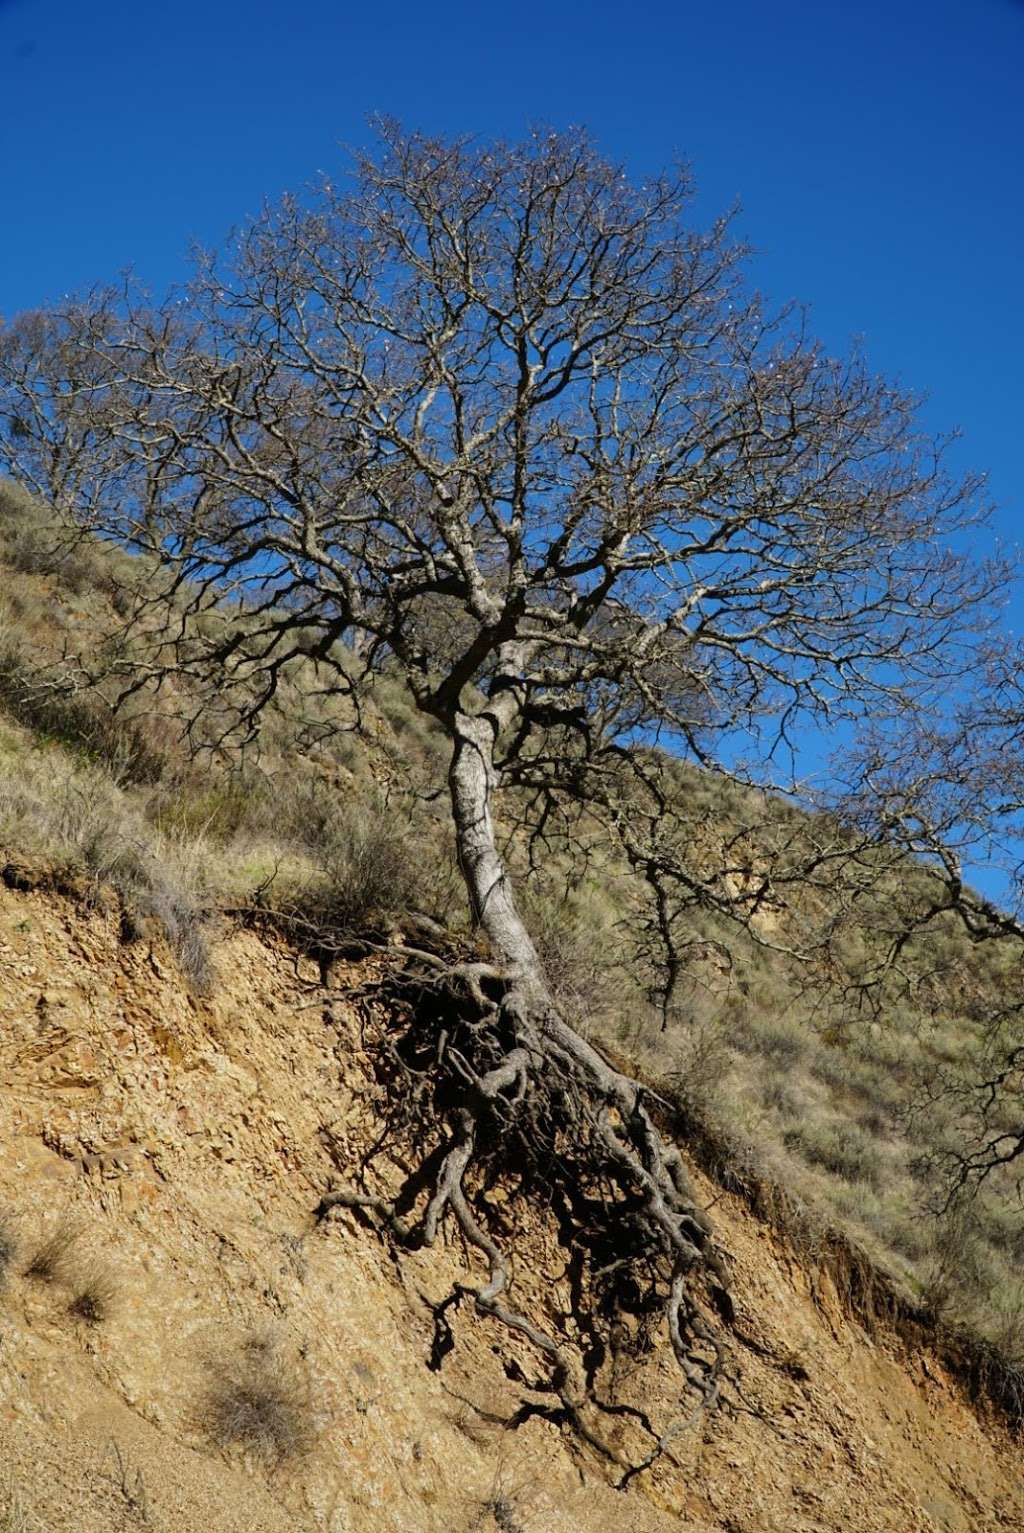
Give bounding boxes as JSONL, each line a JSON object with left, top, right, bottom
{"left": 0, "top": 888, "right": 1024, "bottom": 1533}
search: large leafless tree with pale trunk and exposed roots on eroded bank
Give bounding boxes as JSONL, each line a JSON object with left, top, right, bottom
{"left": 0, "top": 126, "right": 999, "bottom": 1459}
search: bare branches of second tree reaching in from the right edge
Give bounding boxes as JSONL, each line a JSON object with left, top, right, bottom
{"left": 845, "top": 641, "right": 1024, "bottom": 1213}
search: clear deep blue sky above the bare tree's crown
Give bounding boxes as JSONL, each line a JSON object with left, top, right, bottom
{"left": 0, "top": 0, "right": 1024, "bottom": 570}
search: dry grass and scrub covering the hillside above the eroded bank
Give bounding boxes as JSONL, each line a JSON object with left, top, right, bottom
{"left": 0, "top": 484, "right": 1024, "bottom": 1404}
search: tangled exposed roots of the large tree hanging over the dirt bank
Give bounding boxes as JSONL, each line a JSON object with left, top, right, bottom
{"left": 316, "top": 950, "right": 731, "bottom": 1487}
